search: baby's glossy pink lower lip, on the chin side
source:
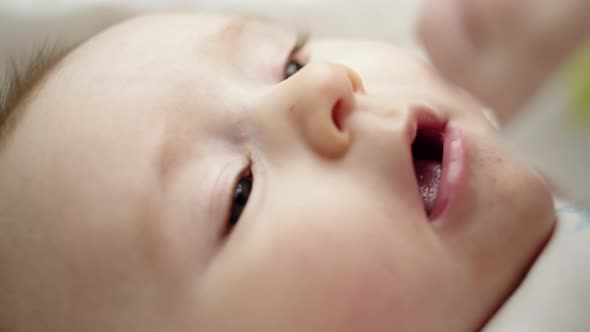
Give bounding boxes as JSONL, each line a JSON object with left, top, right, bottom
{"left": 430, "top": 127, "right": 466, "bottom": 221}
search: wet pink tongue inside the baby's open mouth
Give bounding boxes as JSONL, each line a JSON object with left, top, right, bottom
{"left": 414, "top": 160, "right": 442, "bottom": 214}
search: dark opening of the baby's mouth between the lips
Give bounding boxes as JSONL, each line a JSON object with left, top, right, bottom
{"left": 412, "top": 121, "right": 445, "bottom": 217}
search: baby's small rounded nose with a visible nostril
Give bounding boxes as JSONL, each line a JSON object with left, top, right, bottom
{"left": 283, "top": 63, "right": 364, "bottom": 158}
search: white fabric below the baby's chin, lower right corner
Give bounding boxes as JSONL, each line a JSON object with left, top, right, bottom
{"left": 484, "top": 206, "right": 590, "bottom": 332}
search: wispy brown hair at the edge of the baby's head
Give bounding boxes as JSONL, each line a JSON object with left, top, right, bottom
{"left": 0, "top": 43, "right": 75, "bottom": 143}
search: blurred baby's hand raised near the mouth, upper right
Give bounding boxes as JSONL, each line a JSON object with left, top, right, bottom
{"left": 417, "top": 0, "right": 590, "bottom": 123}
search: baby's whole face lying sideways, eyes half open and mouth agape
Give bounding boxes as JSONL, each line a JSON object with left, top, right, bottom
{"left": 0, "top": 14, "right": 553, "bottom": 332}
